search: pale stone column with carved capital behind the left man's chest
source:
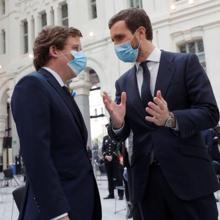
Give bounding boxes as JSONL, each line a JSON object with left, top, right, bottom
{"left": 70, "top": 72, "right": 92, "bottom": 147}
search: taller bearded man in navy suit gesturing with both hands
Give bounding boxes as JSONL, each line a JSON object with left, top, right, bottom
{"left": 103, "top": 8, "right": 219, "bottom": 220}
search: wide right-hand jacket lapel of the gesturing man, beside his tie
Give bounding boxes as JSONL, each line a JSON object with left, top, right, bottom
{"left": 154, "top": 51, "right": 175, "bottom": 97}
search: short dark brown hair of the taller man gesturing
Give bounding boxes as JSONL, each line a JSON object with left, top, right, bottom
{"left": 108, "top": 8, "right": 153, "bottom": 41}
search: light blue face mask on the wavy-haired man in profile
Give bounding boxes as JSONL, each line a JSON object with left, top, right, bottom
{"left": 67, "top": 50, "right": 87, "bottom": 76}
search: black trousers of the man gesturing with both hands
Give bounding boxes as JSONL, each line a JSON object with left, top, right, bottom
{"left": 133, "top": 165, "right": 218, "bottom": 220}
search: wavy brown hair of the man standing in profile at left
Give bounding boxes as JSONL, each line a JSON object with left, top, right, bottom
{"left": 33, "top": 26, "right": 82, "bottom": 70}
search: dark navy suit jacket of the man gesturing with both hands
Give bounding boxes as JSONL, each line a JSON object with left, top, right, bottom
{"left": 108, "top": 51, "right": 219, "bottom": 205}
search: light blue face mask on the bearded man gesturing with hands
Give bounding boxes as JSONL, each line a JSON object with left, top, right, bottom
{"left": 115, "top": 42, "right": 140, "bottom": 62}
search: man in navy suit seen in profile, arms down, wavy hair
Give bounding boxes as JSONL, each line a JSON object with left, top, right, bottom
{"left": 11, "top": 26, "right": 101, "bottom": 220}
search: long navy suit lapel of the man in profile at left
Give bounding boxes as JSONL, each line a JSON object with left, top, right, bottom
{"left": 38, "top": 69, "right": 87, "bottom": 142}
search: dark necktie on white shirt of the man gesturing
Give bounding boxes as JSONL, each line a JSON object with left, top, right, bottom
{"left": 140, "top": 61, "right": 153, "bottom": 106}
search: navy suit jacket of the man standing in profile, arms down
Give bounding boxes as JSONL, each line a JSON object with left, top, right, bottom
{"left": 11, "top": 69, "right": 101, "bottom": 220}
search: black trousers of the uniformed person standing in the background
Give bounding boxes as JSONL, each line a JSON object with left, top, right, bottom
{"left": 105, "top": 158, "right": 124, "bottom": 197}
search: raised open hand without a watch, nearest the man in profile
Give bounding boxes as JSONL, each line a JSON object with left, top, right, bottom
{"left": 103, "top": 92, "right": 127, "bottom": 129}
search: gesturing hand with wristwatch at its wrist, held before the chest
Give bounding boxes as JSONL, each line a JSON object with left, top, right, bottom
{"left": 145, "top": 91, "right": 170, "bottom": 126}
